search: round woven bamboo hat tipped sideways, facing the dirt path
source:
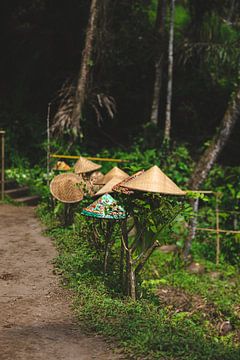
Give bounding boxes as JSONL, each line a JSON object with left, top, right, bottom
{"left": 50, "top": 173, "right": 84, "bottom": 204}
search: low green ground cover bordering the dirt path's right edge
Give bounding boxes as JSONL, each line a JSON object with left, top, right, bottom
{"left": 38, "top": 205, "right": 240, "bottom": 360}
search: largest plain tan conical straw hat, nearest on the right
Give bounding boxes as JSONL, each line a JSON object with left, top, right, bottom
{"left": 123, "top": 165, "right": 186, "bottom": 195}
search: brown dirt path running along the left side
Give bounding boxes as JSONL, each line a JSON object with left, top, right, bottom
{"left": 0, "top": 205, "right": 122, "bottom": 360}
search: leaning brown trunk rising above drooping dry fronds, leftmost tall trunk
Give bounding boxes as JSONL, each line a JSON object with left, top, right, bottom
{"left": 72, "top": 0, "right": 99, "bottom": 135}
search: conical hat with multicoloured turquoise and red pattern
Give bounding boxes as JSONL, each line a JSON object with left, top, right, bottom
{"left": 82, "top": 194, "right": 126, "bottom": 220}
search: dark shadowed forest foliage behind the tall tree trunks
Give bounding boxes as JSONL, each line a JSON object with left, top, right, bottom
{"left": 0, "top": 0, "right": 239, "bottom": 164}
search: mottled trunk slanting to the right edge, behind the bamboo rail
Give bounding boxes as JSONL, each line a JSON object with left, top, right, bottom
{"left": 184, "top": 89, "right": 240, "bottom": 259}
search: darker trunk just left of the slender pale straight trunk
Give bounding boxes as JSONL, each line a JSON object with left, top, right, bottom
{"left": 151, "top": 0, "right": 166, "bottom": 125}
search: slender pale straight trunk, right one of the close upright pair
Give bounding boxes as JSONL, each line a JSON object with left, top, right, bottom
{"left": 164, "top": 0, "right": 175, "bottom": 142}
